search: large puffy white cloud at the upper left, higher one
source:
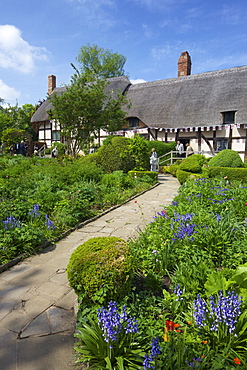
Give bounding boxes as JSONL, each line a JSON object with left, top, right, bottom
{"left": 0, "top": 24, "right": 48, "bottom": 73}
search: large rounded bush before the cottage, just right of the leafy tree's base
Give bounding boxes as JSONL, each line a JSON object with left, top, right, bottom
{"left": 96, "top": 136, "right": 135, "bottom": 173}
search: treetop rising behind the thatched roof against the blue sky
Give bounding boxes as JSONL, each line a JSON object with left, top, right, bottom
{"left": 77, "top": 44, "right": 126, "bottom": 78}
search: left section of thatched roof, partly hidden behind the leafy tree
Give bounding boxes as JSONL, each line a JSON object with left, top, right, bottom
{"left": 31, "top": 76, "right": 130, "bottom": 123}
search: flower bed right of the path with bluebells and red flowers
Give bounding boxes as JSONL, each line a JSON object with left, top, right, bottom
{"left": 76, "top": 179, "right": 247, "bottom": 370}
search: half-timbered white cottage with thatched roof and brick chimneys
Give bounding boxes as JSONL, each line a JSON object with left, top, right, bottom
{"left": 31, "top": 51, "right": 247, "bottom": 159}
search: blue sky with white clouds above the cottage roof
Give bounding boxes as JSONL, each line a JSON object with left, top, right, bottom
{"left": 0, "top": 0, "right": 247, "bottom": 106}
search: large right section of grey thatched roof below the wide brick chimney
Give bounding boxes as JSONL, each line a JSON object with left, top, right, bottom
{"left": 127, "top": 66, "right": 247, "bottom": 128}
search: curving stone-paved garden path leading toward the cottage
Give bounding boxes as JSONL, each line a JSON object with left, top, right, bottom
{"left": 0, "top": 174, "right": 179, "bottom": 370}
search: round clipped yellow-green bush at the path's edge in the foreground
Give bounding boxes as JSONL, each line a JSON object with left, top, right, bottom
{"left": 67, "top": 236, "right": 132, "bottom": 304}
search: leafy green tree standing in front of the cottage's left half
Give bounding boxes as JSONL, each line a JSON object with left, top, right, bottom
{"left": 49, "top": 73, "right": 127, "bottom": 156}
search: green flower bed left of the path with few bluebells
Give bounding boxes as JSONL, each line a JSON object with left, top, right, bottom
{"left": 0, "top": 156, "right": 153, "bottom": 266}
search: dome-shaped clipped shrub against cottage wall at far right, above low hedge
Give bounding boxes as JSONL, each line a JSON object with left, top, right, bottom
{"left": 208, "top": 149, "right": 243, "bottom": 168}
